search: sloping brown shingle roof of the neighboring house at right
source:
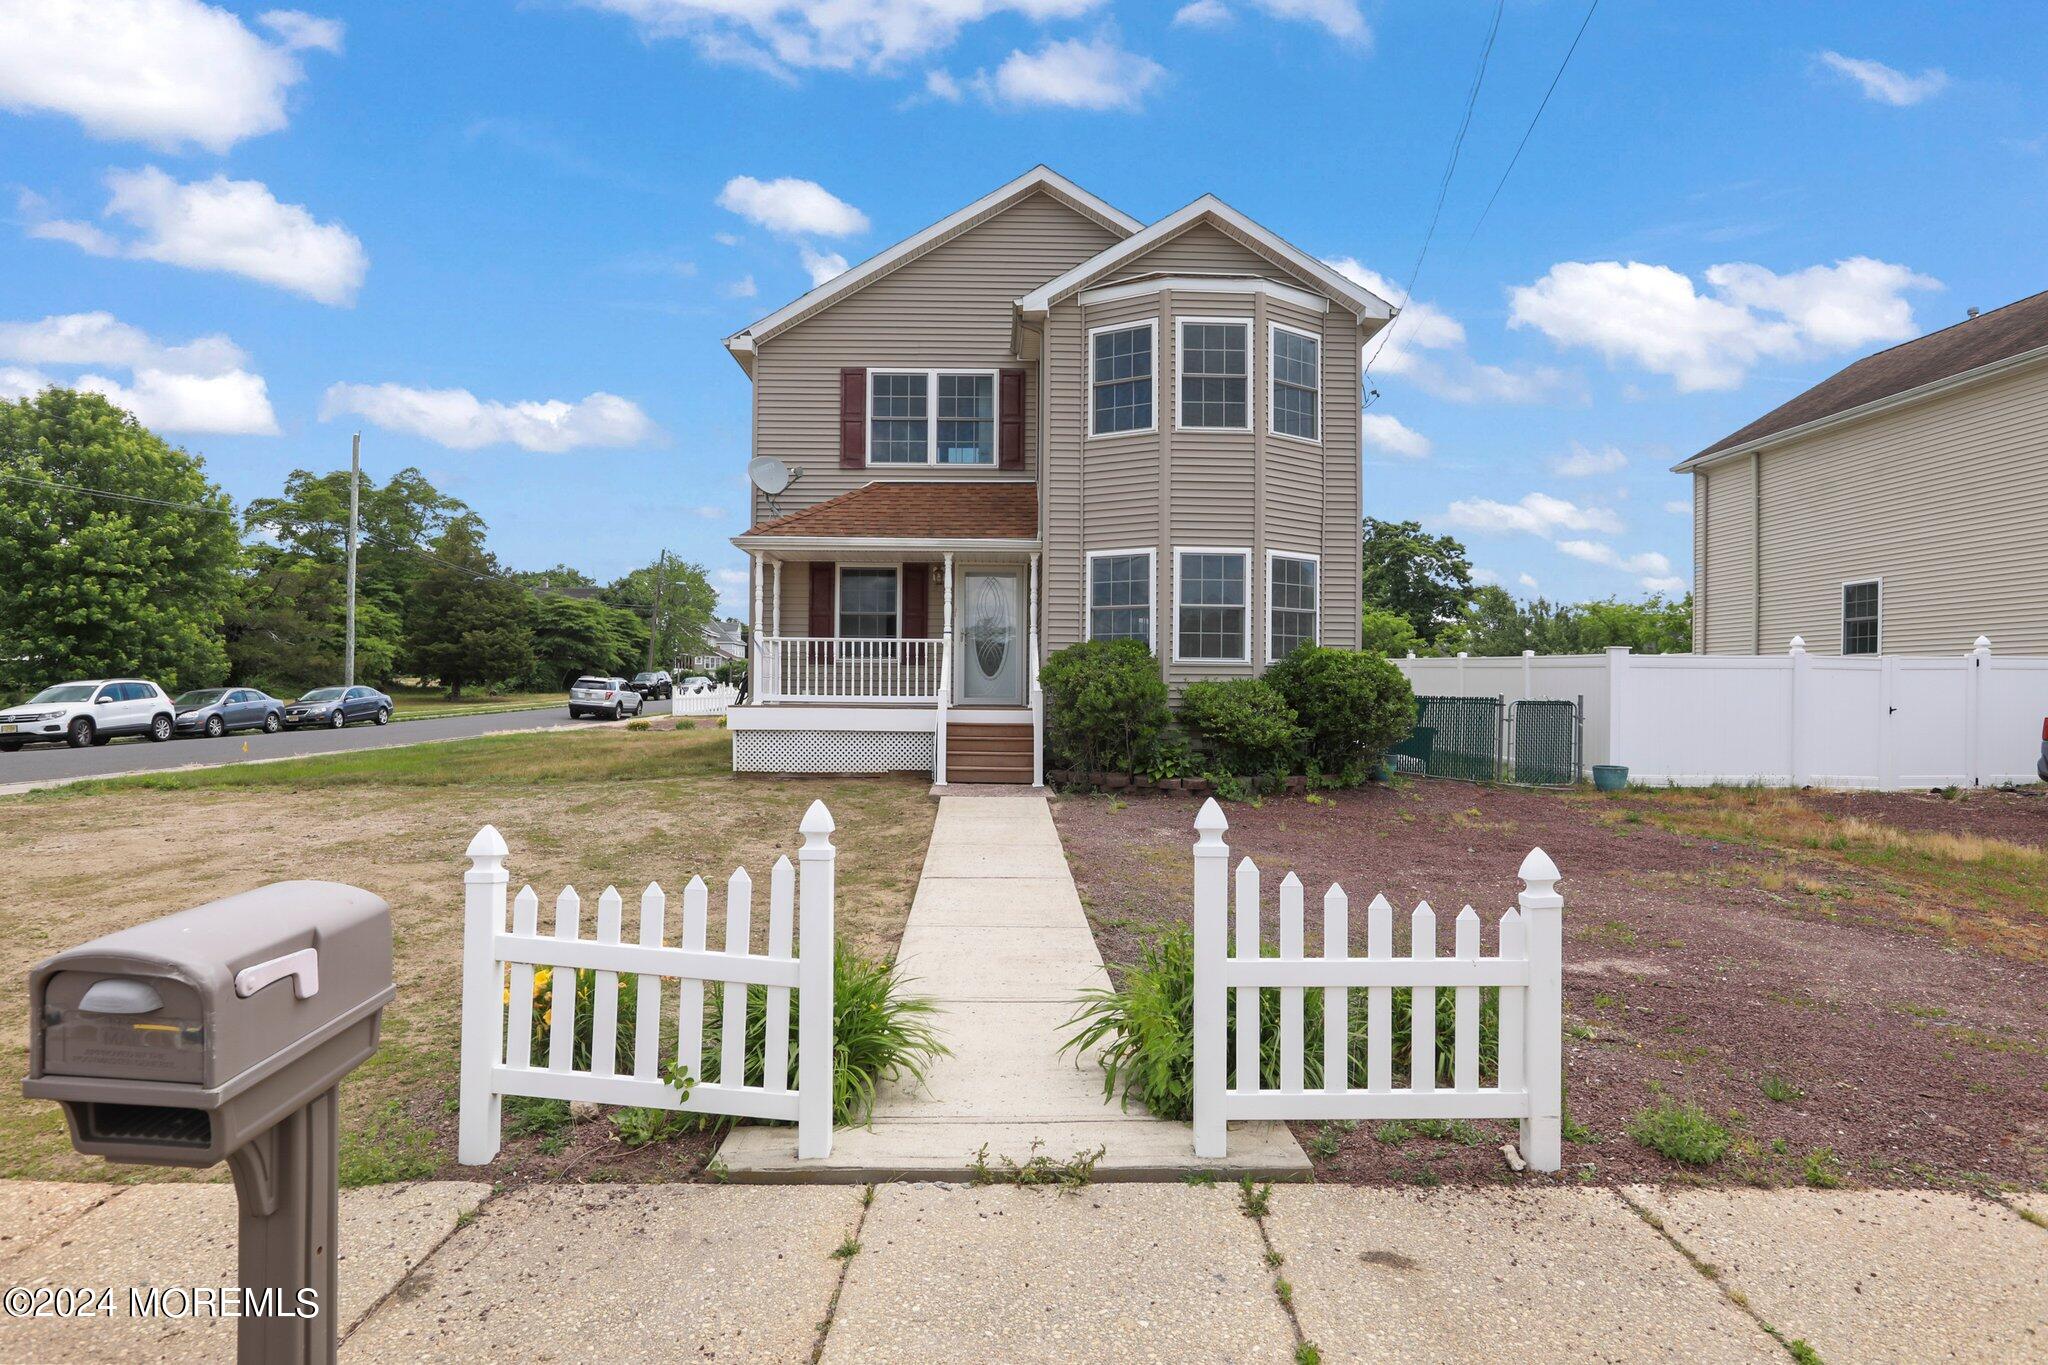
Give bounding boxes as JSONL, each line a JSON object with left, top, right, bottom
{"left": 1675, "top": 293, "right": 2048, "bottom": 471}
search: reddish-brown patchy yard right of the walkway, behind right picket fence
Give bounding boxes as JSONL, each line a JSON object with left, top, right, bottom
{"left": 1055, "top": 782, "right": 2048, "bottom": 1189}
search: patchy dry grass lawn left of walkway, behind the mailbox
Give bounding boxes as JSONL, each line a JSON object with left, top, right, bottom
{"left": 0, "top": 718, "right": 934, "bottom": 1183}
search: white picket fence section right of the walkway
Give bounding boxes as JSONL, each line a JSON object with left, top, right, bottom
{"left": 1194, "top": 800, "right": 1565, "bottom": 1171}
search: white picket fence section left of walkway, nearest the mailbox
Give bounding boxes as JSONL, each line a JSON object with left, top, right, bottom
{"left": 457, "top": 800, "right": 838, "bottom": 1166}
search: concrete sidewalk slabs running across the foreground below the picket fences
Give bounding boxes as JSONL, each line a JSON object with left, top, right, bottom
{"left": 0, "top": 1181, "right": 2048, "bottom": 1365}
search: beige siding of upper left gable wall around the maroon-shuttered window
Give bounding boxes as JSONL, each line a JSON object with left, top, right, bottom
{"left": 754, "top": 194, "right": 1116, "bottom": 520}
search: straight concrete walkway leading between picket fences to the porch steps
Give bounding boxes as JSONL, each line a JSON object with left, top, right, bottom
{"left": 719, "top": 794, "right": 1309, "bottom": 1183}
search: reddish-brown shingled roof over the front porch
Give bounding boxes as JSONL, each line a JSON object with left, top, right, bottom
{"left": 733, "top": 479, "right": 1038, "bottom": 548}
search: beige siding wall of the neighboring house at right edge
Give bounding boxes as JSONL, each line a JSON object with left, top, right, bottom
{"left": 1736, "top": 364, "right": 2048, "bottom": 655}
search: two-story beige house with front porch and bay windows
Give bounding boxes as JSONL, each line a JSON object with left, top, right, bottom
{"left": 725, "top": 166, "right": 1391, "bottom": 782}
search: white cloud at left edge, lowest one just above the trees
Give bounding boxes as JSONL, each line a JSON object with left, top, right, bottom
{"left": 0, "top": 313, "right": 276, "bottom": 436}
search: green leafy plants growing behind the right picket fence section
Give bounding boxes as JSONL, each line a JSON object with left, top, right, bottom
{"left": 1061, "top": 925, "right": 1501, "bottom": 1119}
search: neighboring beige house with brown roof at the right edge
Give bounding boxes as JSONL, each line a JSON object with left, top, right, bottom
{"left": 1677, "top": 293, "right": 2048, "bottom": 655}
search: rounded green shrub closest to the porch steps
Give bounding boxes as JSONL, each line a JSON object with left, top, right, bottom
{"left": 1038, "top": 641, "right": 1171, "bottom": 772}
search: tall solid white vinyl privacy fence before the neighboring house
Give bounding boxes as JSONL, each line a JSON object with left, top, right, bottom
{"left": 1395, "top": 636, "right": 2048, "bottom": 790}
